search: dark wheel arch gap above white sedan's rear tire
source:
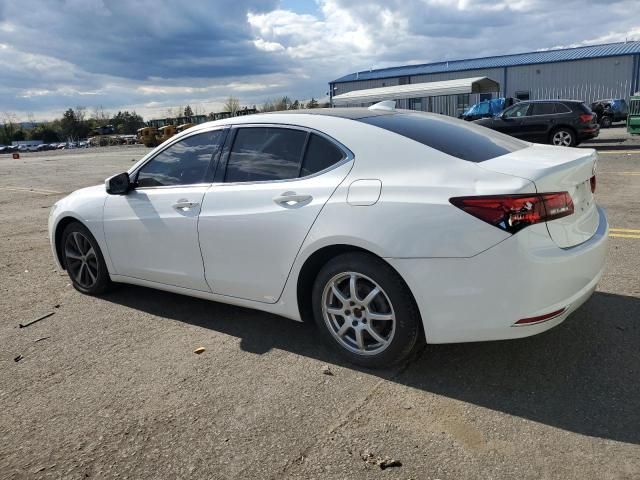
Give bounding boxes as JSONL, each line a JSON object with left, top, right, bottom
{"left": 296, "top": 243, "right": 424, "bottom": 335}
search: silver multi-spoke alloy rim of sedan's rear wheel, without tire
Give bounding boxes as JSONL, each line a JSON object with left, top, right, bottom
{"left": 322, "top": 272, "right": 396, "bottom": 355}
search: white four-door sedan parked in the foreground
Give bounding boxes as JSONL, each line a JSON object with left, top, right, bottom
{"left": 49, "top": 104, "right": 608, "bottom": 367}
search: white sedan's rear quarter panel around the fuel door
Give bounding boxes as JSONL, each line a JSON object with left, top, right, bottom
{"left": 292, "top": 118, "right": 535, "bottom": 258}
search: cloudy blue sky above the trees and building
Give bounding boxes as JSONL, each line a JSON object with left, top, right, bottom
{"left": 0, "top": 0, "right": 640, "bottom": 121}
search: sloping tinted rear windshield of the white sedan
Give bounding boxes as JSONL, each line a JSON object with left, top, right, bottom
{"left": 358, "top": 113, "right": 529, "bottom": 163}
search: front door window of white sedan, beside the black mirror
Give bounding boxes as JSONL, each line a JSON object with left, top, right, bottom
{"left": 137, "top": 130, "right": 224, "bottom": 187}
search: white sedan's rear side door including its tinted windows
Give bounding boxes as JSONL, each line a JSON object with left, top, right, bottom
{"left": 199, "top": 125, "right": 352, "bottom": 303}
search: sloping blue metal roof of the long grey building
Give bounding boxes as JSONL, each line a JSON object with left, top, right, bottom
{"left": 331, "top": 41, "right": 640, "bottom": 83}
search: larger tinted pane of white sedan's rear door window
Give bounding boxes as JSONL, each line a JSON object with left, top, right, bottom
{"left": 225, "top": 127, "right": 307, "bottom": 182}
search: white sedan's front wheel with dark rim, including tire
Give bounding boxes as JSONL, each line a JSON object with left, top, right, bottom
{"left": 60, "top": 222, "right": 112, "bottom": 295}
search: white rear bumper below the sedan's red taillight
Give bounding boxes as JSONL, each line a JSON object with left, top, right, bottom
{"left": 387, "top": 204, "right": 609, "bottom": 343}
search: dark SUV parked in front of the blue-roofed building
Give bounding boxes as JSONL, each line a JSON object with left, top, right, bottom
{"left": 475, "top": 100, "right": 600, "bottom": 147}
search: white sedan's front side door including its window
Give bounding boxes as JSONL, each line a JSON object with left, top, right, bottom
{"left": 104, "top": 129, "right": 226, "bottom": 291}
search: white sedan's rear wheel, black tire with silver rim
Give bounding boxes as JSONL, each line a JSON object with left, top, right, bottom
{"left": 312, "top": 252, "right": 422, "bottom": 368}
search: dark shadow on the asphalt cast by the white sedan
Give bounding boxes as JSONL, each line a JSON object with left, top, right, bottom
{"left": 105, "top": 286, "right": 640, "bottom": 444}
